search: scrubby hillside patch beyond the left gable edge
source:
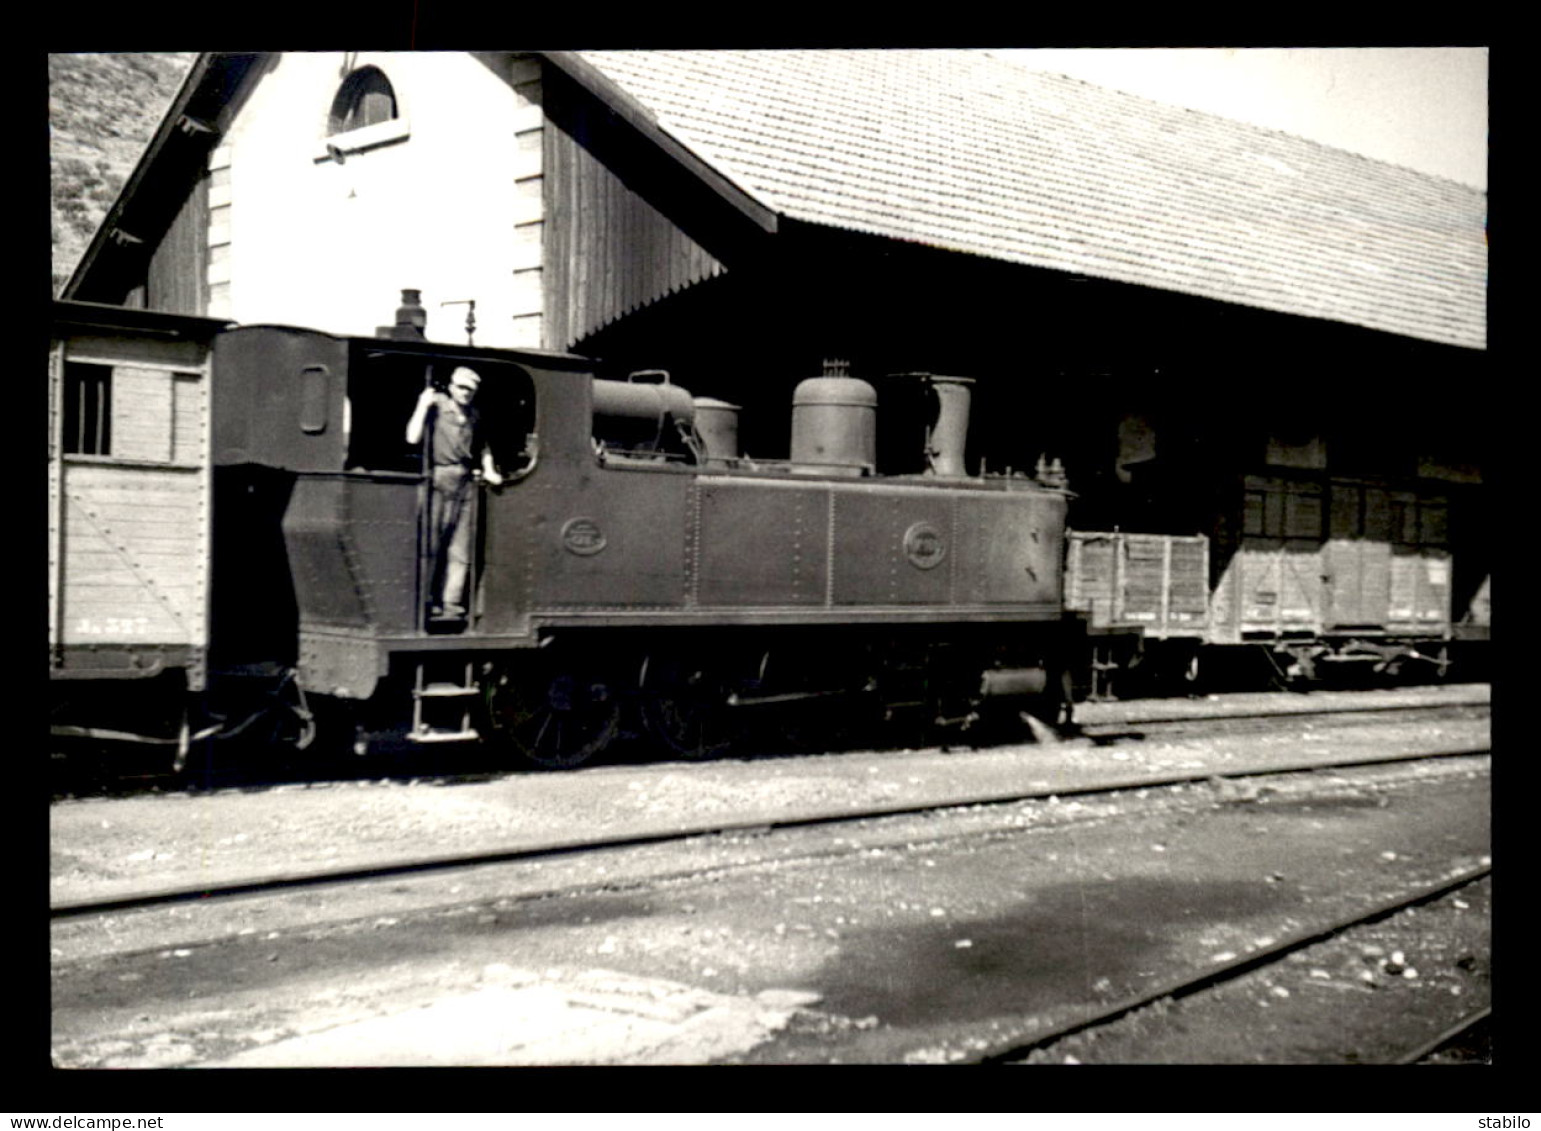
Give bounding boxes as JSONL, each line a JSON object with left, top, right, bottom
{"left": 48, "top": 52, "right": 196, "bottom": 294}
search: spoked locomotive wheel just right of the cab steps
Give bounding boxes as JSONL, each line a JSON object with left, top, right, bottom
{"left": 487, "top": 672, "right": 621, "bottom": 769}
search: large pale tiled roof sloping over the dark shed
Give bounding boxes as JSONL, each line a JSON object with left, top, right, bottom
{"left": 579, "top": 49, "right": 1487, "bottom": 348}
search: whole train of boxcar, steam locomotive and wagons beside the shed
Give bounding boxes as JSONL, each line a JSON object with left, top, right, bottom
{"left": 48, "top": 302, "right": 1490, "bottom": 766}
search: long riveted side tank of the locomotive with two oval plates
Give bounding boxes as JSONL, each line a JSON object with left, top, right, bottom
{"left": 478, "top": 368, "right": 1065, "bottom": 635}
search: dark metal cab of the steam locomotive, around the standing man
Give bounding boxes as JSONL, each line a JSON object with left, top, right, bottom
{"left": 213, "top": 327, "right": 560, "bottom": 681}
